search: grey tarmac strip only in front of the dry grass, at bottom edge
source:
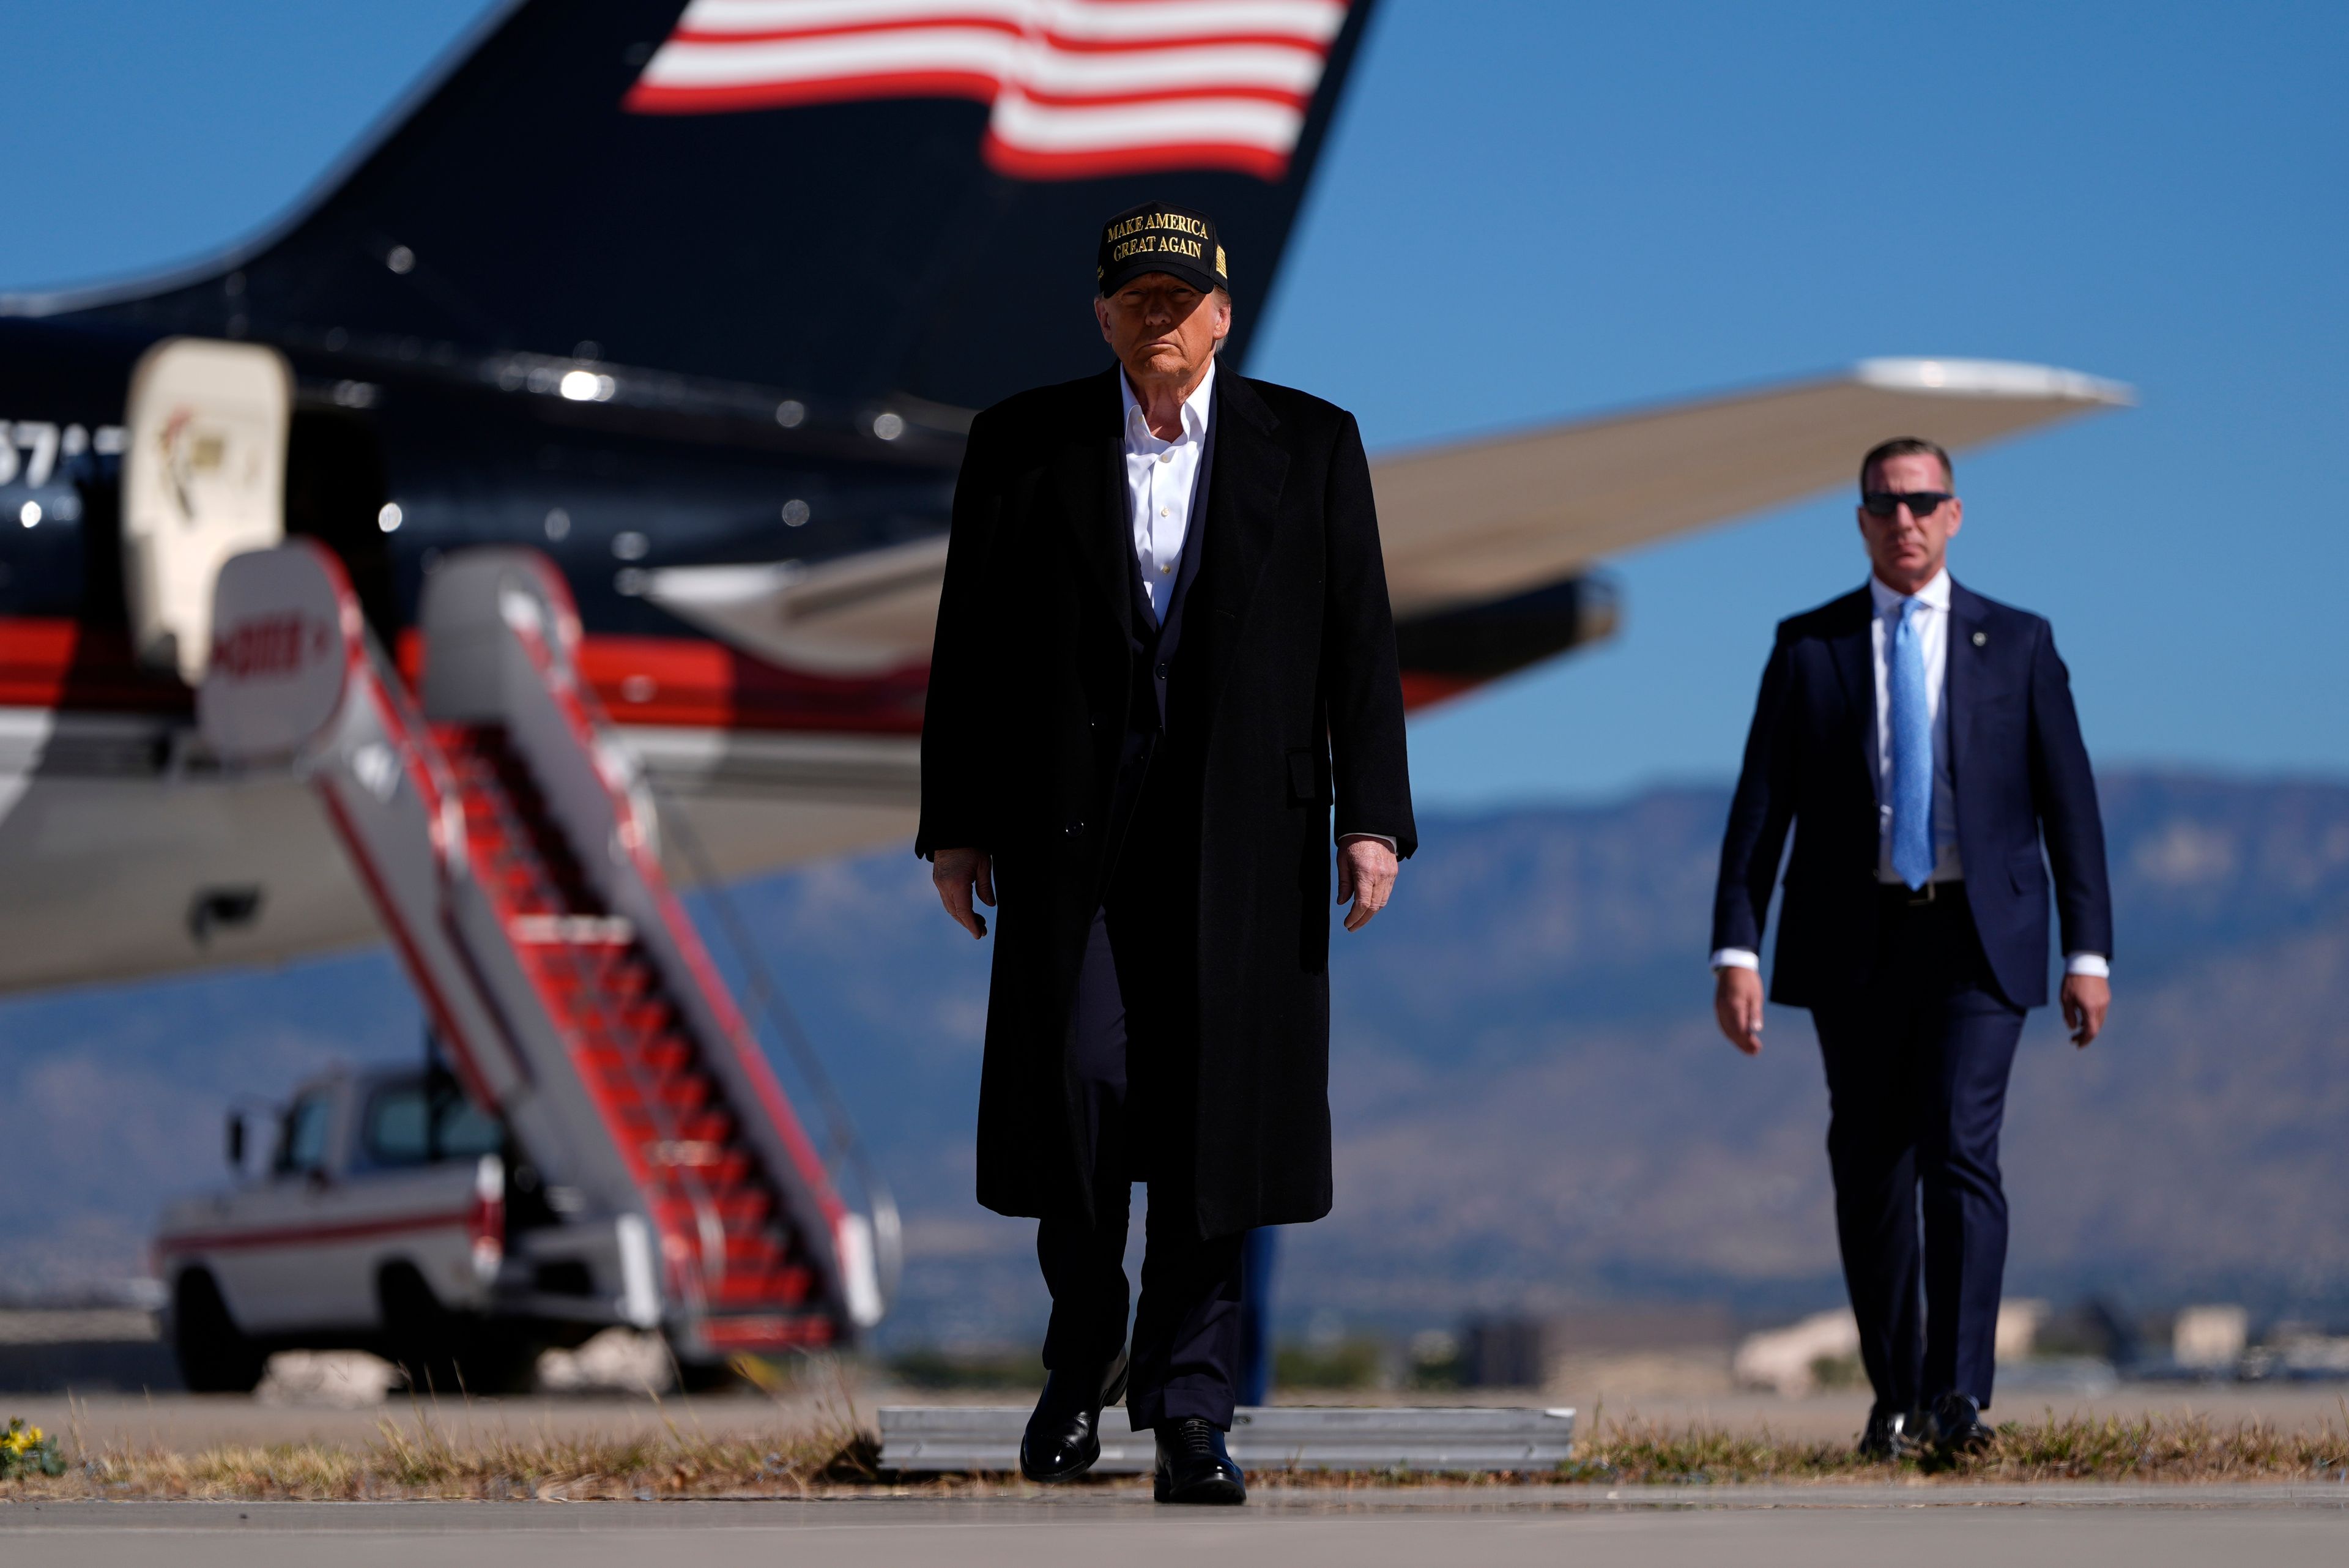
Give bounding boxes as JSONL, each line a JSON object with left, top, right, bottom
{"left": 0, "top": 1486, "right": 2349, "bottom": 1568}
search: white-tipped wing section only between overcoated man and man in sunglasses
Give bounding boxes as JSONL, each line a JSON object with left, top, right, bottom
{"left": 1370, "top": 360, "right": 2136, "bottom": 620}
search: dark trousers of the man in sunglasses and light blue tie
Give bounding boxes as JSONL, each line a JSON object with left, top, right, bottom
{"left": 1811, "top": 884, "right": 2022, "bottom": 1411}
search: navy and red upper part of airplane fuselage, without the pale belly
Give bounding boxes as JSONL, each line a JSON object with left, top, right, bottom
{"left": 0, "top": 320, "right": 963, "bottom": 736}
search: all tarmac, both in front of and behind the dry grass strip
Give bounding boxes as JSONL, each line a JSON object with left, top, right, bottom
{"left": 0, "top": 1380, "right": 2349, "bottom": 1568}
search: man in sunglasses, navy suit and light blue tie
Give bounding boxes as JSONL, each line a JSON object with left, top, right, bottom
{"left": 1712, "top": 440, "right": 2112, "bottom": 1457}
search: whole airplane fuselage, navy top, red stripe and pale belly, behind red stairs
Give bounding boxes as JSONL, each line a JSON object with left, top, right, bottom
{"left": 0, "top": 320, "right": 961, "bottom": 987}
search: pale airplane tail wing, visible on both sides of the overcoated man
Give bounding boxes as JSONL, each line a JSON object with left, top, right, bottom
{"left": 646, "top": 360, "right": 2136, "bottom": 675}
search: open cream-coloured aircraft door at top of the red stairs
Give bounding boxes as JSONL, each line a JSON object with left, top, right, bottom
{"left": 122, "top": 338, "right": 294, "bottom": 686}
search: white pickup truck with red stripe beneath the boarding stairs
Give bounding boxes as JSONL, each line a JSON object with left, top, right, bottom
{"left": 155, "top": 1069, "right": 658, "bottom": 1392}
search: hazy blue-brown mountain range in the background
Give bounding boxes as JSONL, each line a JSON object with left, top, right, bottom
{"left": 0, "top": 771, "right": 2349, "bottom": 1342}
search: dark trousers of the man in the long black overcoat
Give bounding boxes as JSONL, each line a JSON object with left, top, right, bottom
{"left": 1036, "top": 905, "right": 1247, "bottom": 1432}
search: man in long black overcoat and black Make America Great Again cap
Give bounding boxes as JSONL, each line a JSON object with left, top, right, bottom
{"left": 916, "top": 204, "right": 1417, "bottom": 1502}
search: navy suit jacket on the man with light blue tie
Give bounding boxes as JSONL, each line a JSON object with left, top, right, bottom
{"left": 1712, "top": 583, "right": 2112, "bottom": 1006}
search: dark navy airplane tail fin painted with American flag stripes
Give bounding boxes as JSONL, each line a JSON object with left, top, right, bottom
{"left": 13, "top": 0, "right": 1374, "bottom": 409}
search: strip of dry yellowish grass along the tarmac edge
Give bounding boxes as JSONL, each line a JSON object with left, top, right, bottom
{"left": 13, "top": 1411, "right": 2349, "bottom": 1502}
